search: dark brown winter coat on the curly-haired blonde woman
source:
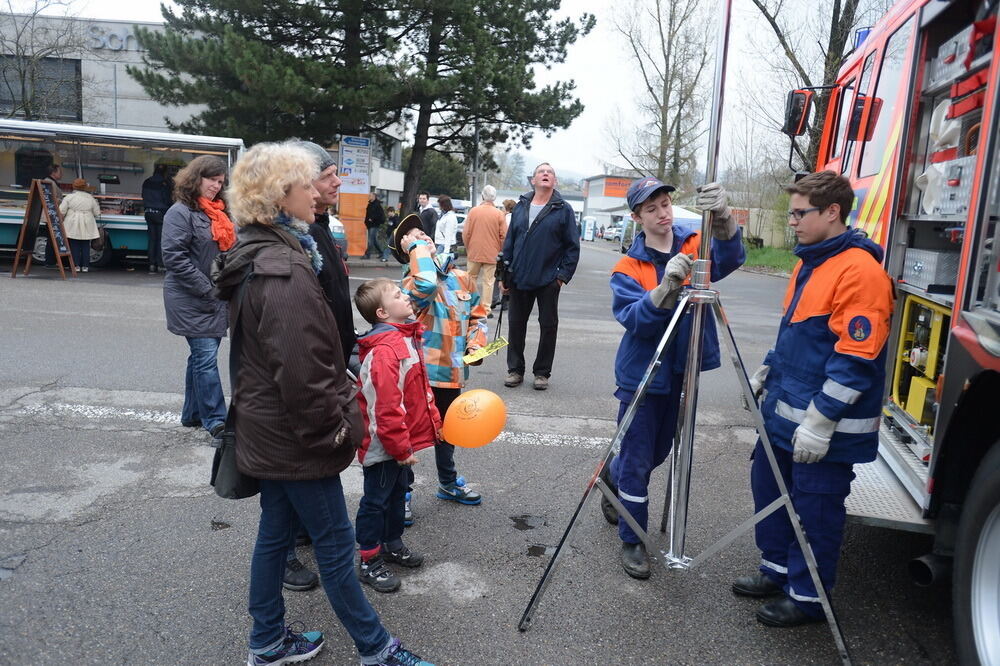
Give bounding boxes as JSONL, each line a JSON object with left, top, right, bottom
{"left": 213, "top": 225, "right": 364, "bottom": 481}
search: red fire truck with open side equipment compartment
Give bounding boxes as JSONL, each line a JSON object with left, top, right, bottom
{"left": 783, "top": 0, "right": 1000, "bottom": 665}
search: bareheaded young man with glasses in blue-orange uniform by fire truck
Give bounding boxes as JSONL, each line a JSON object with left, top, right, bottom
{"left": 733, "top": 171, "right": 893, "bottom": 627}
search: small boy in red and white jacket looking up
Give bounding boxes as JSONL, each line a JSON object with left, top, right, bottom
{"left": 354, "top": 278, "right": 441, "bottom": 592}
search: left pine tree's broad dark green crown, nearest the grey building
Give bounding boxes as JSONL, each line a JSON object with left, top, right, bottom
{"left": 129, "top": 0, "right": 408, "bottom": 144}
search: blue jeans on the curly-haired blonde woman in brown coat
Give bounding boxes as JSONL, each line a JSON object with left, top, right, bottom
{"left": 249, "top": 476, "right": 391, "bottom": 663}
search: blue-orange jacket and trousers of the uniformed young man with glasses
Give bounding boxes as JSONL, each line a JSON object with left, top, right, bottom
{"left": 750, "top": 229, "right": 893, "bottom": 616}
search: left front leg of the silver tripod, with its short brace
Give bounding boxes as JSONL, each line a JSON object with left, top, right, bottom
{"left": 517, "top": 294, "right": 689, "bottom": 631}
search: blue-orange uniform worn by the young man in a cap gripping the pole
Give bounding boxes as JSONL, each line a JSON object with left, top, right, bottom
{"left": 611, "top": 224, "right": 746, "bottom": 543}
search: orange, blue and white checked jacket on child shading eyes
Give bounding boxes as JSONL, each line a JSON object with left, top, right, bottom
{"left": 402, "top": 241, "right": 487, "bottom": 388}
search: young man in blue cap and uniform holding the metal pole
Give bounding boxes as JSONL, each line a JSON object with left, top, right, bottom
{"left": 601, "top": 178, "right": 746, "bottom": 579}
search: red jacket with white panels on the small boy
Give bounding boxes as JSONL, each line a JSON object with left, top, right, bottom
{"left": 358, "top": 321, "right": 441, "bottom": 466}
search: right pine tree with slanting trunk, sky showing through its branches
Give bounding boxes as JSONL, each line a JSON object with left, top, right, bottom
{"left": 402, "top": 0, "right": 594, "bottom": 206}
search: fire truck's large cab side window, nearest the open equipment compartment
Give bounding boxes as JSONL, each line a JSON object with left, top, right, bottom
{"left": 858, "top": 18, "right": 913, "bottom": 178}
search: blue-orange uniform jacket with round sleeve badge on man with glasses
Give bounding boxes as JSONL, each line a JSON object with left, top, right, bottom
{"left": 761, "top": 230, "right": 893, "bottom": 463}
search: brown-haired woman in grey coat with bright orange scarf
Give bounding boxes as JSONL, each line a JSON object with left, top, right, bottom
{"left": 161, "top": 155, "right": 236, "bottom": 437}
